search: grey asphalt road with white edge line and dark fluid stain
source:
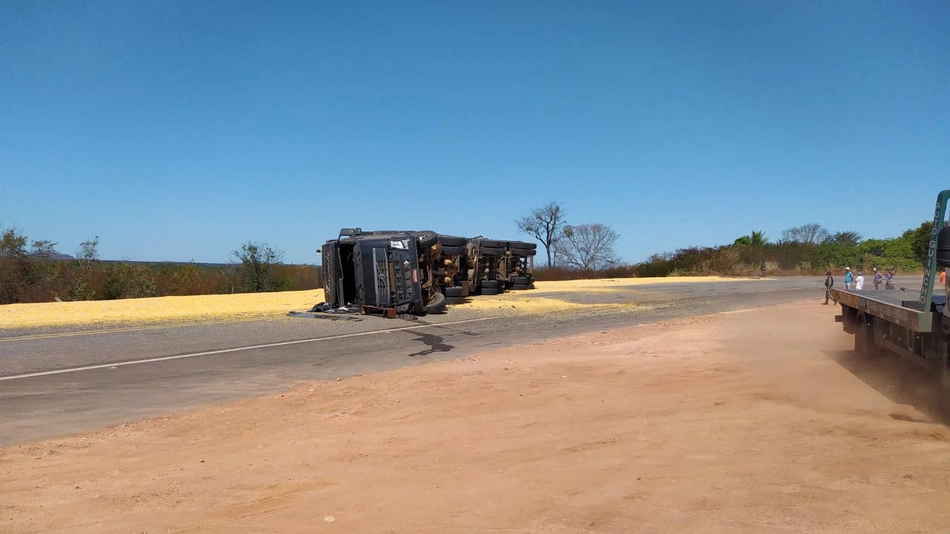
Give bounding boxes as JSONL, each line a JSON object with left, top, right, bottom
{"left": 0, "top": 278, "right": 919, "bottom": 444}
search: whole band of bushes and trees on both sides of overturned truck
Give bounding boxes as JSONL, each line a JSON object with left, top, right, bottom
{"left": 0, "top": 214, "right": 933, "bottom": 304}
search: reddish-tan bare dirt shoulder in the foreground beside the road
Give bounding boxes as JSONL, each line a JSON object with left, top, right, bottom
{"left": 7, "top": 302, "right": 950, "bottom": 533}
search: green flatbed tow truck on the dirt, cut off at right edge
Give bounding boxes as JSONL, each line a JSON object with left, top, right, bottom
{"left": 831, "top": 190, "right": 950, "bottom": 388}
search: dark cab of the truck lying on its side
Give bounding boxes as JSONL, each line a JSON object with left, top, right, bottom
{"left": 321, "top": 228, "right": 445, "bottom": 316}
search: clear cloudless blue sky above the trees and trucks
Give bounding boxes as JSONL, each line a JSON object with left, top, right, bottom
{"left": 0, "top": 0, "right": 950, "bottom": 263}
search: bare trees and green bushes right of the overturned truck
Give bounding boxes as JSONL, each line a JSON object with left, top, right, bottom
{"left": 514, "top": 202, "right": 933, "bottom": 280}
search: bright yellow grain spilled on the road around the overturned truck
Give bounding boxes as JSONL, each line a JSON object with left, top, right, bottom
{"left": 0, "top": 276, "right": 748, "bottom": 330}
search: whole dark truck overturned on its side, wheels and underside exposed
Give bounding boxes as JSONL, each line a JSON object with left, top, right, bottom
{"left": 322, "top": 228, "right": 537, "bottom": 317}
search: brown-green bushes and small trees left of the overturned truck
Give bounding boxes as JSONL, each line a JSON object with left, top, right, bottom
{"left": 0, "top": 228, "right": 323, "bottom": 304}
